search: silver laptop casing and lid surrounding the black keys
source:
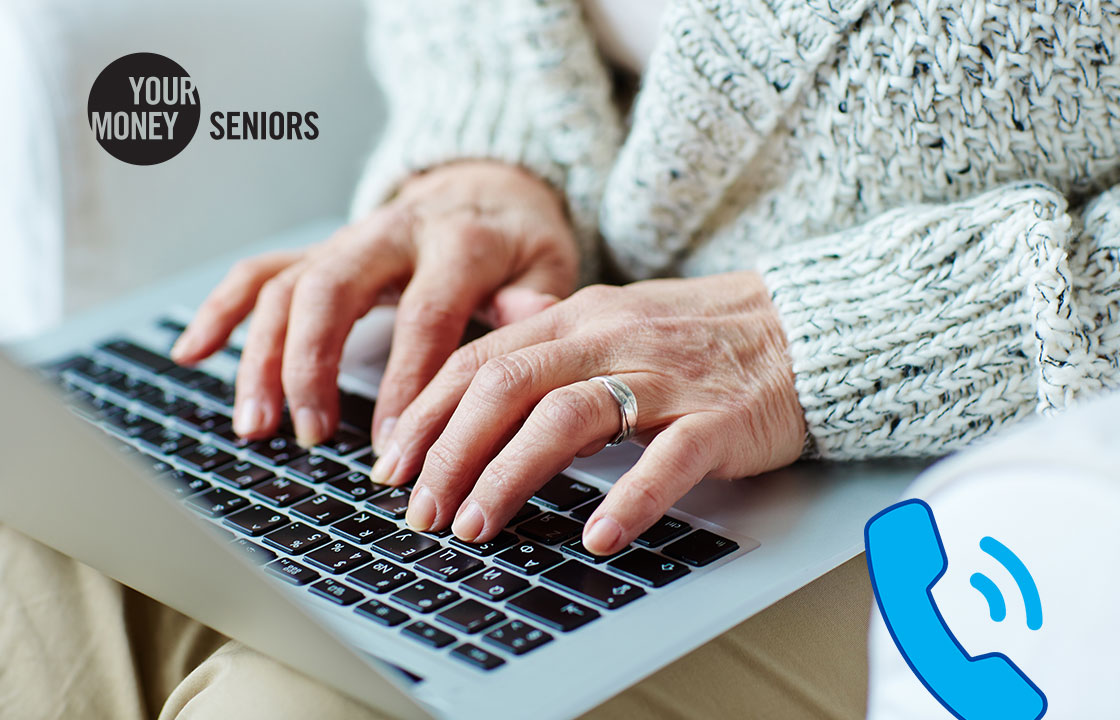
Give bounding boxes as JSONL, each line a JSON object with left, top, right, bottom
{"left": 0, "top": 223, "right": 923, "bottom": 720}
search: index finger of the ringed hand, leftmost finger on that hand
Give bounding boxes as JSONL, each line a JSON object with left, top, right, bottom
{"left": 371, "top": 308, "right": 564, "bottom": 485}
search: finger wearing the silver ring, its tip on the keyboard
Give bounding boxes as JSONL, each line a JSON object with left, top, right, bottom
{"left": 451, "top": 373, "right": 661, "bottom": 542}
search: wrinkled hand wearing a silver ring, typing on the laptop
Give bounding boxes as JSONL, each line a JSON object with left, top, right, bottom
{"left": 373, "top": 272, "right": 805, "bottom": 554}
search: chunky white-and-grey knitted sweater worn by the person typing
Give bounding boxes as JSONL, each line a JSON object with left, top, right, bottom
{"left": 354, "top": 0, "right": 1120, "bottom": 458}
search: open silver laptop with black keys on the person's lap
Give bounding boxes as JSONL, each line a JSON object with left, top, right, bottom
{"left": 0, "top": 223, "right": 925, "bottom": 720}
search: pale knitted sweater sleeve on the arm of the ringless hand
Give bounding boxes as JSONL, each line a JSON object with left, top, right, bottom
{"left": 352, "top": 0, "right": 622, "bottom": 282}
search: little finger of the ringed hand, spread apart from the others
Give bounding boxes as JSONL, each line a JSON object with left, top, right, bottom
{"left": 584, "top": 414, "right": 720, "bottom": 555}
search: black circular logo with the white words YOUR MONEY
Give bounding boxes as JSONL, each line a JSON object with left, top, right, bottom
{"left": 88, "top": 53, "right": 202, "bottom": 165}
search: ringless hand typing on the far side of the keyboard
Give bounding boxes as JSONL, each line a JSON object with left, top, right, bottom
{"left": 171, "top": 161, "right": 578, "bottom": 451}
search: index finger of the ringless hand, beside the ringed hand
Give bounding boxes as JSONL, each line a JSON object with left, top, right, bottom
{"left": 373, "top": 237, "right": 502, "bottom": 453}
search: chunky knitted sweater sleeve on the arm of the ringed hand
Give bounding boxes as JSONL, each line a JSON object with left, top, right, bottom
{"left": 760, "top": 184, "right": 1120, "bottom": 459}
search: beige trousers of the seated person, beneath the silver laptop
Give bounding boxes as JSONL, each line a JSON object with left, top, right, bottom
{"left": 0, "top": 526, "right": 870, "bottom": 720}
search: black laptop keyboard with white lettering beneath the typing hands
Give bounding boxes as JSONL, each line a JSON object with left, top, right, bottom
{"left": 46, "top": 331, "right": 749, "bottom": 672}
